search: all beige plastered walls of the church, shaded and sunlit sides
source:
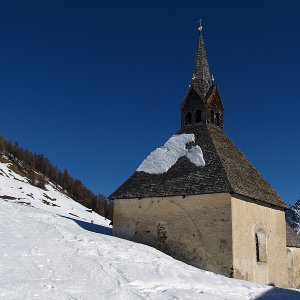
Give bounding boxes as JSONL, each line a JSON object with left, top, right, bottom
{"left": 113, "top": 193, "right": 300, "bottom": 288}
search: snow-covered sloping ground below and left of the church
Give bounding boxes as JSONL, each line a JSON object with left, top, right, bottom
{"left": 0, "top": 158, "right": 300, "bottom": 300}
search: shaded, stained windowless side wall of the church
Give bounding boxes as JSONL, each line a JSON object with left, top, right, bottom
{"left": 113, "top": 193, "right": 233, "bottom": 276}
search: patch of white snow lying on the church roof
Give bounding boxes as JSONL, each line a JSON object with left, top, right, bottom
{"left": 137, "top": 134, "right": 205, "bottom": 174}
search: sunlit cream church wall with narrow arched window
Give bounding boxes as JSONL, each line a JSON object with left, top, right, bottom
{"left": 231, "top": 195, "right": 289, "bottom": 287}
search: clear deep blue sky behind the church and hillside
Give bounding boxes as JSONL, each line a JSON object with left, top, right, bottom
{"left": 0, "top": 0, "right": 300, "bottom": 203}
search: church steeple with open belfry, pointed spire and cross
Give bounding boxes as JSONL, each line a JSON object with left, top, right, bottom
{"left": 180, "top": 19, "right": 224, "bottom": 129}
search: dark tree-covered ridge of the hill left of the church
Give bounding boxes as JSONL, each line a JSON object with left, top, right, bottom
{"left": 0, "top": 136, "right": 112, "bottom": 219}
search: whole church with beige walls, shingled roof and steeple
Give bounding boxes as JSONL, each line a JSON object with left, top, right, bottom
{"left": 109, "top": 24, "right": 300, "bottom": 288}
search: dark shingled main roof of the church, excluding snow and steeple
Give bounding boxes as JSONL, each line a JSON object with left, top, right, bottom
{"left": 109, "top": 124, "right": 288, "bottom": 208}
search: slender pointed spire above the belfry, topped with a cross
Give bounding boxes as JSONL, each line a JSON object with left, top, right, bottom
{"left": 192, "top": 19, "right": 213, "bottom": 97}
